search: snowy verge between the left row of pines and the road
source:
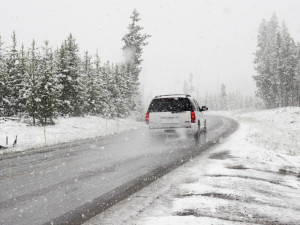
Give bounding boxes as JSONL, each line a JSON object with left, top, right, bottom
{"left": 0, "top": 116, "right": 145, "bottom": 154}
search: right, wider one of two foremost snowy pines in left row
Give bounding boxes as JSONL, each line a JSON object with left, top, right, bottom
{"left": 38, "top": 41, "right": 59, "bottom": 125}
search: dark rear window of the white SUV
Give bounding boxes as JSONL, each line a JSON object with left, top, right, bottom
{"left": 148, "top": 98, "right": 192, "bottom": 112}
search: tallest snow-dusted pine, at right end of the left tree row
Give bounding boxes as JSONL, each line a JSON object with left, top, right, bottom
{"left": 122, "top": 9, "right": 150, "bottom": 111}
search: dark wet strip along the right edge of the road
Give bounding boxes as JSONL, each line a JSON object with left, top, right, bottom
{"left": 45, "top": 117, "right": 239, "bottom": 225}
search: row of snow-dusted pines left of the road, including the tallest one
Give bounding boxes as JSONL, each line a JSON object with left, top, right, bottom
{"left": 0, "top": 10, "right": 149, "bottom": 124}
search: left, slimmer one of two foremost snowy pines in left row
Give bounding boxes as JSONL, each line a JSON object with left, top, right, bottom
{"left": 25, "top": 40, "right": 41, "bottom": 125}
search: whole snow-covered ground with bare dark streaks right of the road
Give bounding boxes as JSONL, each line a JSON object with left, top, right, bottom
{"left": 86, "top": 107, "right": 300, "bottom": 225}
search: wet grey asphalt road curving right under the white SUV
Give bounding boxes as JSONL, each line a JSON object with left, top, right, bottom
{"left": 0, "top": 116, "right": 238, "bottom": 225}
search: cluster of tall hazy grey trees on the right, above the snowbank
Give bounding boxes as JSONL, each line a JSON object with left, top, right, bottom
{"left": 254, "top": 14, "right": 300, "bottom": 108}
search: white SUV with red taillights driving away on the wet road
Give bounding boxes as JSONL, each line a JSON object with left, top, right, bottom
{"left": 146, "top": 94, "right": 208, "bottom": 133}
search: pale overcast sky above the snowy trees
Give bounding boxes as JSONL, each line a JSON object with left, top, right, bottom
{"left": 0, "top": 0, "right": 300, "bottom": 102}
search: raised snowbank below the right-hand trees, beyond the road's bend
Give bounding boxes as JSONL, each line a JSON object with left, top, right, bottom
{"left": 237, "top": 107, "right": 300, "bottom": 155}
